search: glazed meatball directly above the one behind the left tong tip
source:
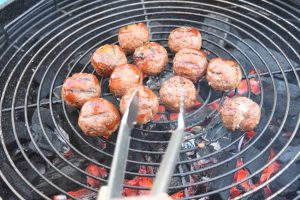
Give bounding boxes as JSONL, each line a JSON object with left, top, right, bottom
{"left": 109, "top": 64, "right": 143, "bottom": 97}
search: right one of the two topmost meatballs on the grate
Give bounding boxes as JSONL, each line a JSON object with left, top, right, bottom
{"left": 168, "top": 27, "right": 202, "bottom": 53}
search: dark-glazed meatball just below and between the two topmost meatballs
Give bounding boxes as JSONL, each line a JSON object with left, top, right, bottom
{"left": 133, "top": 42, "right": 168, "bottom": 75}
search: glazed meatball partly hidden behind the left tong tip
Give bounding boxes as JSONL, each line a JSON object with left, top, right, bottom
{"left": 120, "top": 86, "right": 159, "bottom": 124}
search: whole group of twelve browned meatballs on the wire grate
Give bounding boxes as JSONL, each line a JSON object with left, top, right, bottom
{"left": 61, "top": 23, "right": 261, "bottom": 136}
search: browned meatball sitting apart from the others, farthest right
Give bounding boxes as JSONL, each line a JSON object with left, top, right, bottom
{"left": 221, "top": 97, "right": 260, "bottom": 131}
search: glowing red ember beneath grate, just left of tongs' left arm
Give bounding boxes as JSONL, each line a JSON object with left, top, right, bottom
{"left": 85, "top": 164, "right": 107, "bottom": 188}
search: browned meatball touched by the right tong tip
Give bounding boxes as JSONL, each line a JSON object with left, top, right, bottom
{"left": 159, "top": 76, "right": 197, "bottom": 112}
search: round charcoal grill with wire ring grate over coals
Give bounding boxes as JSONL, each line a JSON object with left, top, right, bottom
{"left": 0, "top": 0, "right": 300, "bottom": 199}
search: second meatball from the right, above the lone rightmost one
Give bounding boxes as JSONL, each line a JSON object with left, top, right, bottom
{"left": 206, "top": 58, "right": 242, "bottom": 91}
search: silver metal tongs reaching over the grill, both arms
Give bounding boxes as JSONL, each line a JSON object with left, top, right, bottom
{"left": 97, "top": 90, "right": 185, "bottom": 200}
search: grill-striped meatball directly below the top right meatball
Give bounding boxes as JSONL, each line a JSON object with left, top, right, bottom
{"left": 173, "top": 48, "right": 207, "bottom": 82}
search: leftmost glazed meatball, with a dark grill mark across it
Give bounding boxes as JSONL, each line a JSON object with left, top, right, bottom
{"left": 61, "top": 73, "right": 101, "bottom": 108}
